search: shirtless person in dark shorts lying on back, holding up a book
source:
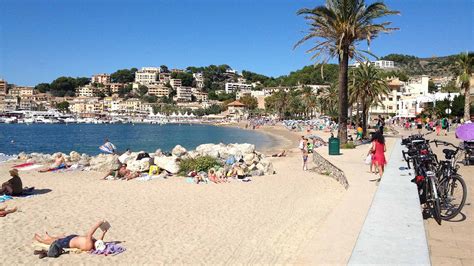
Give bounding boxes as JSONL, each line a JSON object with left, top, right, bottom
{"left": 34, "top": 220, "right": 108, "bottom": 258}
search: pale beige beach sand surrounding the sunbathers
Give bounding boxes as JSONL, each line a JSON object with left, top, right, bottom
{"left": 0, "top": 124, "right": 348, "bottom": 264}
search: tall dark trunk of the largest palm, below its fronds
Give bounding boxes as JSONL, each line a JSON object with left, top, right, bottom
{"left": 337, "top": 47, "right": 349, "bottom": 144}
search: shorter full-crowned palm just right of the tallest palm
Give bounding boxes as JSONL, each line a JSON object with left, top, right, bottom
{"left": 349, "top": 63, "right": 390, "bottom": 137}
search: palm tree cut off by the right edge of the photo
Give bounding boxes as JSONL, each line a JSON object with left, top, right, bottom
{"left": 456, "top": 53, "right": 474, "bottom": 121}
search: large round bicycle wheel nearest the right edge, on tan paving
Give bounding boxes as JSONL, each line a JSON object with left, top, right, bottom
{"left": 439, "top": 175, "right": 467, "bottom": 220}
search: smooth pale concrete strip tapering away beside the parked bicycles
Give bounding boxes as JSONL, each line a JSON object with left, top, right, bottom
{"left": 349, "top": 140, "right": 430, "bottom": 265}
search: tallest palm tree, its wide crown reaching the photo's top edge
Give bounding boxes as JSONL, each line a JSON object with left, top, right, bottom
{"left": 294, "top": 0, "right": 399, "bottom": 143}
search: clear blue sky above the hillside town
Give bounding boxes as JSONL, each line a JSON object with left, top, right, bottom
{"left": 0, "top": 0, "right": 474, "bottom": 86}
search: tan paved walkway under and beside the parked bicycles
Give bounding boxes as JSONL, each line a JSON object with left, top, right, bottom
{"left": 425, "top": 136, "right": 474, "bottom": 265}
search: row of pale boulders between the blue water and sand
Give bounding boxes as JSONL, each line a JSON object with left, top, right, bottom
{"left": 18, "top": 143, "right": 275, "bottom": 176}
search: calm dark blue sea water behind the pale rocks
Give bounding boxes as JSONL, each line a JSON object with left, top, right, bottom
{"left": 0, "top": 124, "right": 275, "bottom": 161}
